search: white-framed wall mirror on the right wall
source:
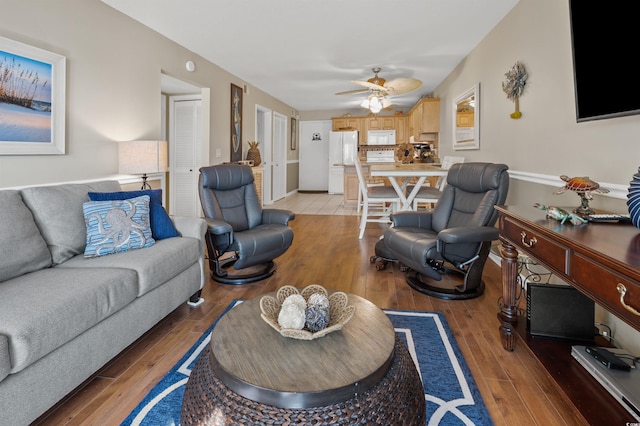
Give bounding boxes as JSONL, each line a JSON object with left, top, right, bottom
{"left": 453, "top": 83, "right": 480, "bottom": 151}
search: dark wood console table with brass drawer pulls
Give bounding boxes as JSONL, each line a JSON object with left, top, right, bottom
{"left": 496, "top": 206, "right": 640, "bottom": 424}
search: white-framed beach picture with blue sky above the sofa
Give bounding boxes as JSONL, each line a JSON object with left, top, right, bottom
{"left": 0, "top": 37, "right": 66, "bottom": 155}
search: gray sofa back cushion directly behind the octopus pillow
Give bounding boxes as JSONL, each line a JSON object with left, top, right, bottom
{"left": 21, "top": 180, "right": 120, "bottom": 265}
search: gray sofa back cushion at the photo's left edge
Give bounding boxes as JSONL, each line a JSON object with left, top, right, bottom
{"left": 0, "top": 190, "right": 51, "bottom": 285}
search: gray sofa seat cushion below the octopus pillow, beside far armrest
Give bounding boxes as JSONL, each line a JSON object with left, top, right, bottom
{"left": 58, "top": 237, "right": 201, "bottom": 296}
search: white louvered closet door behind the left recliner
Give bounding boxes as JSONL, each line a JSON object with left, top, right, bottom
{"left": 169, "top": 97, "right": 202, "bottom": 217}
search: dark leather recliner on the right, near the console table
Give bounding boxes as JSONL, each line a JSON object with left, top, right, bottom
{"left": 372, "top": 163, "right": 509, "bottom": 299}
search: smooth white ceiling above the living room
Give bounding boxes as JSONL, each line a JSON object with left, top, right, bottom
{"left": 102, "top": 0, "right": 518, "bottom": 111}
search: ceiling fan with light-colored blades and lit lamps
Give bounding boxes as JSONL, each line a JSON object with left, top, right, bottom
{"left": 336, "top": 67, "right": 422, "bottom": 114}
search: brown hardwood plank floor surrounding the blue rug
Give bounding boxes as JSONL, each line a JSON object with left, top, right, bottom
{"left": 35, "top": 194, "right": 585, "bottom": 426}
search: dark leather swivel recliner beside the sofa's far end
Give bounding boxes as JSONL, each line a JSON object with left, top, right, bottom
{"left": 198, "top": 164, "right": 295, "bottom": 284}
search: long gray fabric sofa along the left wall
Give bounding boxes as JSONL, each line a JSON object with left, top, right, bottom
{"left": 0, "top": 181, "right": 206, "bottom": 425}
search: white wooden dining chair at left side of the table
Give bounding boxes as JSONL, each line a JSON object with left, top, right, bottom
{"left": 354, "top": 159, "right": 400, "bottom": 239}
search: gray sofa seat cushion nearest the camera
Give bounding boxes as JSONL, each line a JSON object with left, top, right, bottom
{"left": 0, "top": 268, "right": 137, "bottom": 373}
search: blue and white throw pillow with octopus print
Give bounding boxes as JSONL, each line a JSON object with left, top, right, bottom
{"left": 82, "top": 195, "right": 155, "bottom": 257}
